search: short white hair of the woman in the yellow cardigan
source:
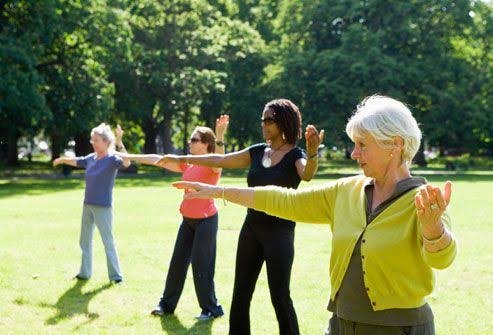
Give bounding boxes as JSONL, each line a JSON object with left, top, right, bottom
{"left": 346, "top": 95, "right": 422, "bottom": 166}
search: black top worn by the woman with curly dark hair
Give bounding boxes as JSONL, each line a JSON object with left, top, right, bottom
{"left": 247, "top": 143, "right": 306, "bottom": 227}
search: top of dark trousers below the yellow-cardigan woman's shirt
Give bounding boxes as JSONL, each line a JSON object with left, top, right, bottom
{"left": 325, "top": 315, "right": 435, "bottom": 335}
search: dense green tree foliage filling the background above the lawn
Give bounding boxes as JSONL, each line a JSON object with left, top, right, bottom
{"left": 0, "top": 0, "right": 493, "bottom": 162}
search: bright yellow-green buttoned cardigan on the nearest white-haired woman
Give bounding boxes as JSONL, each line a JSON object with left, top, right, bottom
{"left": 253, "top": 176, "right": 457, "bottom": 311}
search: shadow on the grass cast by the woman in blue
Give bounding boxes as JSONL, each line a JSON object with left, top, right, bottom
{"left": 40, "top": 280, "right": 111, "bottom": 325}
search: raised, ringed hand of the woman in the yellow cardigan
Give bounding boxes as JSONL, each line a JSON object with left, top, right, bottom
{"left": 414, "top": 181, "right": 452, "bottom": 240}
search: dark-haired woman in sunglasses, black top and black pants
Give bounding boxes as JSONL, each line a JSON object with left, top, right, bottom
{"left": 157, "top": 99, "right": 323, "bottom": 335}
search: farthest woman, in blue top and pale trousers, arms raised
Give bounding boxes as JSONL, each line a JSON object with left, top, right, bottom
{"left": 53, "top": 123, "right": 130, "bottom": 284}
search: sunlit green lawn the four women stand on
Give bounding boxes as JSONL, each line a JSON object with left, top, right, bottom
{"left": 0, "top": 173, "right": 493, "bottom": 335}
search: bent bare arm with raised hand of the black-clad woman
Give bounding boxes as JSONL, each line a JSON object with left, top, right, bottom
{"left": 296, "top": 125, "right": 324, "bottom": 181}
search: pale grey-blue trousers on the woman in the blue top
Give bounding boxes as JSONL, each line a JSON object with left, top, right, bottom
{"left": 78, "top": 204, "right": 123, "bottom": 280}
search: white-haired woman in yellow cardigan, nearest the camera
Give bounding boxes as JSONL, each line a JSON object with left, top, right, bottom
{"left": 171, "top": 96, "right": 457, "bottom": 335}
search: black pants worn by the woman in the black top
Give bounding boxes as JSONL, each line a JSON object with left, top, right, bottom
{"left": 229, "top": 216, "right": 299, "bottom": 335}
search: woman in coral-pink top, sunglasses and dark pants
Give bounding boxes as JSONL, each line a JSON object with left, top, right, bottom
{"left": 122, "top": 115, "right": 229, "bottom": 320}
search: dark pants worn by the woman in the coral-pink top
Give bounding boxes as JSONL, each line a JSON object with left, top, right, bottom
{"left": 160, "top": 214, "right": 223, "bottom": 316}
